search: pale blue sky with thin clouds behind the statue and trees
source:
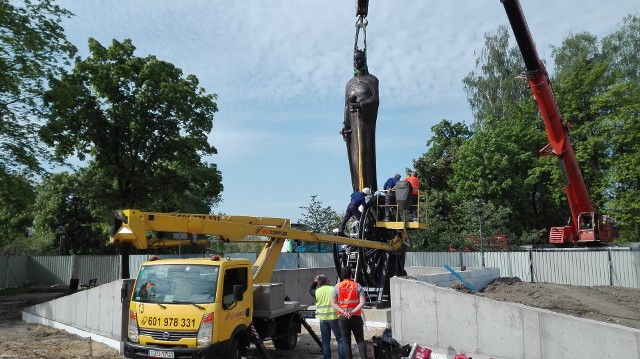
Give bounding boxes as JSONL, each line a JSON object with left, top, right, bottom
{"left": 51, "top": 0, "right": 640, "bottom": 222}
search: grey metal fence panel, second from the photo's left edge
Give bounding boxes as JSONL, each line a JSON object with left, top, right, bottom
{"left": 29, "top": 256, "right": 74, "bottom": 285}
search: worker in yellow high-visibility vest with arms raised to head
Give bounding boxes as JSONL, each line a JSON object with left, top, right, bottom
{"left": 309, "top": 274, "right": 345, "bottom": 359}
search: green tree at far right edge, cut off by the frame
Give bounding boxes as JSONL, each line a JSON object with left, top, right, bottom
{"left": 594, "top": 15, "right": 640, "bottom": 241}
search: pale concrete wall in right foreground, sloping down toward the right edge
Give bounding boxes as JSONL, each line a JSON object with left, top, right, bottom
{"left": 391, "top": 277, "right": 640, "bottom": 359}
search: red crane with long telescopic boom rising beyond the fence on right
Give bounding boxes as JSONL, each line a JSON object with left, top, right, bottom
{"left": 501, "top": 0, "right": 616, "bottom": 244}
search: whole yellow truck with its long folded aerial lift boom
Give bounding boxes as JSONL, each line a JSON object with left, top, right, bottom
{"left": 110, "top": 209, "right": 420, "bottom": 359}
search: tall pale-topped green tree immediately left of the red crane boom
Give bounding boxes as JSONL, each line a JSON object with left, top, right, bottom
{"left": 450, "top": 26, "right": 550, "bottom": 240}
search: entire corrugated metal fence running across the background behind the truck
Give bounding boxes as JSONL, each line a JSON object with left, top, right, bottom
{"left": 0, "top": 249, "right": 640, "bottom": 289}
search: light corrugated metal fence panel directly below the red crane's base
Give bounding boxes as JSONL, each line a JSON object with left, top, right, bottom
{"left": 532, "top": 251, "right": 610, "bottom": 286}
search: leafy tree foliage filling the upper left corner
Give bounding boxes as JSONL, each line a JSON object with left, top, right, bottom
{"left": 0, "top": 0, "right": 76, "bottom": 172}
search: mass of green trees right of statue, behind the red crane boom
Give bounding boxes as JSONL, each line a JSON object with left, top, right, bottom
{"left": 413, "top": 15, "right": 640, "bottom": 250}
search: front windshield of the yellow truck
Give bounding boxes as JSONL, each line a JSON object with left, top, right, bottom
{"left": 133, "top": 264, "right": 220, "bottom": 304}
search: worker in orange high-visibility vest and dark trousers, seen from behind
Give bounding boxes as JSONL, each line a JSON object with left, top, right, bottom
{"left": 331, "top": 267, "right": 367, "bottom": 359}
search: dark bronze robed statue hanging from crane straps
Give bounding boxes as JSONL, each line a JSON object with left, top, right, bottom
{"left": 340, "top": 50, "right": 380, "bottom": 192}
